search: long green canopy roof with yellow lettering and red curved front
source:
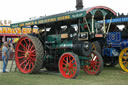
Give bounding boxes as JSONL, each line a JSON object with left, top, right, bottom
{"left": 11, "top": 6, "right": 116, "bottom": 28}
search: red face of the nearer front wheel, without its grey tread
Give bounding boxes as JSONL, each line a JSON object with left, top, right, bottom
{"left": 59, "top": 53, "right": 77, "bottom": 78}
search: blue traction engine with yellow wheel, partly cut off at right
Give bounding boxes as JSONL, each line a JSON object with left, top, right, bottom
{"left": 94, "top": 15, "right": 128, "bottom": 72}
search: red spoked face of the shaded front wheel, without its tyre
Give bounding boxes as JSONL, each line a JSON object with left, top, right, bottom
{"left": 84, "top": 52, "right": 100, "bottom": 75}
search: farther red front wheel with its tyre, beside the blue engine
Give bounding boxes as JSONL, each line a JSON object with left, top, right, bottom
{"left": 84, "top": 51, "right": 103, "bottom": 75}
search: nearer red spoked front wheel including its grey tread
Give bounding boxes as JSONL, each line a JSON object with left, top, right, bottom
{"left": 59, "top": 53, "right": 80, "bottom": 79}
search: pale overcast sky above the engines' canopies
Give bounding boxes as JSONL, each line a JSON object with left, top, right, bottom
{"left": 0, "top": 0, "right": 128, "bottom": 23}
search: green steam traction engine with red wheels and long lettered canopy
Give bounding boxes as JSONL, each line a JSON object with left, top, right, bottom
{"left": 11, "top": 6, "right": 115, "bottom": 78}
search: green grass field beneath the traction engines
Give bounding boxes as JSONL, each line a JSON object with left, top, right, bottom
{"left": 0, "top": 62, "right": 128, "bottom": 85}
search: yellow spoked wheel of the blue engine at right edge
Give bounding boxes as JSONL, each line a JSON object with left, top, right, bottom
{"left": 119, "top": 48, "right": 128, "bottom": 72}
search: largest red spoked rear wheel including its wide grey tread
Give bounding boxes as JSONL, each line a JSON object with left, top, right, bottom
{"left": 15, "top": 36, "right": 44, "bottom": 74}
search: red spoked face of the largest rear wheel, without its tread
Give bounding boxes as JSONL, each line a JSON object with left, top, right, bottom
{"left": 15, "top": 37, "right": 36, "bottom": 73}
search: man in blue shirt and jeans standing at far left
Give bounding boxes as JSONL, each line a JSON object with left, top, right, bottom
{"left": 2, "top": 42, "right": 9, "bottom": 73}
